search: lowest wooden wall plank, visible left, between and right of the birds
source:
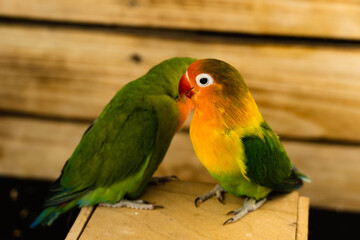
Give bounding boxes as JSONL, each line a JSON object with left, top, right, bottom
{"left": 0, "top": 116, "right": 360, "bottom": 211}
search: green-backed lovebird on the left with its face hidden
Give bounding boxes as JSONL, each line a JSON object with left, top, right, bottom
{"left": 31, "top": 58, "right": 195, "bottom": 227}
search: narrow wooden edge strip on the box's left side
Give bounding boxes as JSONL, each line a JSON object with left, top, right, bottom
{"left": 65, "top": 206, "right": 95, "bottom": 240}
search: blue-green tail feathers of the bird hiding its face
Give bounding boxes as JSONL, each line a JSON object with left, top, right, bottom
{"left": 30, "top": 200, "right": 77, "bottom": 228}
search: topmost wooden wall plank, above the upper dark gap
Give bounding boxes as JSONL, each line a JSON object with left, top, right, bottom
{"left": 0, "top": 0, "right": 360, "bottom": 39}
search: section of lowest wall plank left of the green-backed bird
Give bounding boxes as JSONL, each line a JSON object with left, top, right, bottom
{"left": 0, "top": 117, "right": 87, "bottom": 180}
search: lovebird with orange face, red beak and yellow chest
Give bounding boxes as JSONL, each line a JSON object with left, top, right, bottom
{"left": 179, "top": 59, "right": 308, "bottom": 224}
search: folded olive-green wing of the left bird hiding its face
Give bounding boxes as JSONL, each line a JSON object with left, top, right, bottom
{"left": 46, "top": 94, "right": 158, "bottom": 206}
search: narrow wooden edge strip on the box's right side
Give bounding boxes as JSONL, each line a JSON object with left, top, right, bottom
{"left": 295, "top": 196, "right": 310, "bottom": 240}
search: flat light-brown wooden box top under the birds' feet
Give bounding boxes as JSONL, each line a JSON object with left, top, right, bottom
{"left": 76, "top": 182, "right": 299, "bottom": 240}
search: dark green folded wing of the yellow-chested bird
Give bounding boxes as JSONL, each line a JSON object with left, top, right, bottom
{"left": 242, "top": 122, "right": 302, "bottom": 192}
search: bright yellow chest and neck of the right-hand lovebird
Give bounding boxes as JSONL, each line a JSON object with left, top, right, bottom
{"left": 190, "top": 94, "right": 263, "bottom": 177}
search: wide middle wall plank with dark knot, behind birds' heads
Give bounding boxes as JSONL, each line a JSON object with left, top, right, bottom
{"left": 0, "top": 24, "right": 360, "bottom": 141}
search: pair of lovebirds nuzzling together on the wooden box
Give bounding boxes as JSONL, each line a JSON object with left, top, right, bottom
{"left": 31, "top": 58, "right": 307, "bottom": 227}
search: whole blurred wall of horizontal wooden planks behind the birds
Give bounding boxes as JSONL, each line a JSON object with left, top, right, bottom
{"left": 0, "top": 0, "right": 360, "bottom": 214}
